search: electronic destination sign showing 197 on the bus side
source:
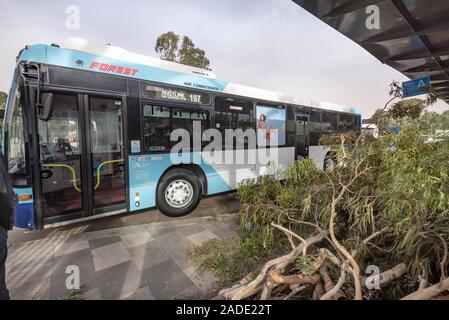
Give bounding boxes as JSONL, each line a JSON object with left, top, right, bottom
{"left": 143, "top": 85, "right": 210, "bottom": 104}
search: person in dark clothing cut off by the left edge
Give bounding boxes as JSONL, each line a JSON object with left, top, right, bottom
{"left": 0, "top": 152, "right": 17, "bottom": 300}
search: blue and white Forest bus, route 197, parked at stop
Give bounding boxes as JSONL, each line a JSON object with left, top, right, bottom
{"left": 2, "top": 38, "right": 361, "bottom": 229}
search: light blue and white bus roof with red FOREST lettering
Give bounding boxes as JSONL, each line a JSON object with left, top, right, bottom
{"left": 19, "top": 38, "right": 361, "bottom": 114}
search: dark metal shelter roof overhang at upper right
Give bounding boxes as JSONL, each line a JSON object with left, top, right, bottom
{"left": 293, "top": 0, "right": 449, "bottom": 103}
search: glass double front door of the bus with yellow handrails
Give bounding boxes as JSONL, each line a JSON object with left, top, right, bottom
{"left": 37, "top": 92, "right": 126, "bottom": 223}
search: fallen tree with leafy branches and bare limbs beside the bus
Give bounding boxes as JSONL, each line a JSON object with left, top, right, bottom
{"left": 194, "top": 84, "right": 449, "bottom": 300}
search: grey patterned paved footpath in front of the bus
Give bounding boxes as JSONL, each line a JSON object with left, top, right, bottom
{"left": 6, "top": 214, "right": 238, "bottom": 299}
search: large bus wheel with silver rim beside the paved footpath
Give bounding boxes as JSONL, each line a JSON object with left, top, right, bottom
{"left": 157, "top": 169, "right": 201, "bottom": 218}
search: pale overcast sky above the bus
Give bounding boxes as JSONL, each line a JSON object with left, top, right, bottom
{"left": 0, "top": 0, "right": 449, "bottom": 117}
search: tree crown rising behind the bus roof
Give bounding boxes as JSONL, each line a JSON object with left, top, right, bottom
{"left": 154, "top": 31, "right": 211, "bottom": 70}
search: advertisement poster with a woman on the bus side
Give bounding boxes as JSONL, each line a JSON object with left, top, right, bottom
{"left": 256, "top": 106, "right": 285, "bottom": 146}
